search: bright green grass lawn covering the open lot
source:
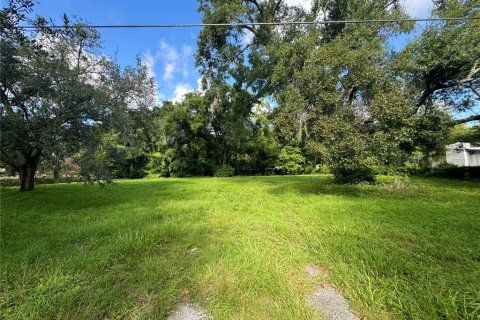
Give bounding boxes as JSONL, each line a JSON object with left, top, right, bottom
{"left": 0, "top": 176, "right": 480, "bottom": 319}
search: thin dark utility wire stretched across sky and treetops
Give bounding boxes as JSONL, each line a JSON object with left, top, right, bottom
{"left": 16, "top": 17, "right": 480, "bottom": 30}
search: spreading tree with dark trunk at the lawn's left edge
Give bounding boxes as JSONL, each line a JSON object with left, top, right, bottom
{"left": 0, "top": 0, "right": 153, "bottom": 191}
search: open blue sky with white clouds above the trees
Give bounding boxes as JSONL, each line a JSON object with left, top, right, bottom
{"left": 0, "top": 0, "right": 431, "bottom": 100}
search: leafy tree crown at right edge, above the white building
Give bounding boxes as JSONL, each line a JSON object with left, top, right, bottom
{"left": 400, "top": 0, "right": 480, "bottom": 118}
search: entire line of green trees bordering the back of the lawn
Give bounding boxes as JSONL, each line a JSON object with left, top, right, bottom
{"left": 0, "top": 0, "right": 480, "bottom": 191}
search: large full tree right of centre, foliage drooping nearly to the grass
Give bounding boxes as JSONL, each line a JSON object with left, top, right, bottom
{"left": 272, "top": 1, "right": 436, "bottom": 181}
